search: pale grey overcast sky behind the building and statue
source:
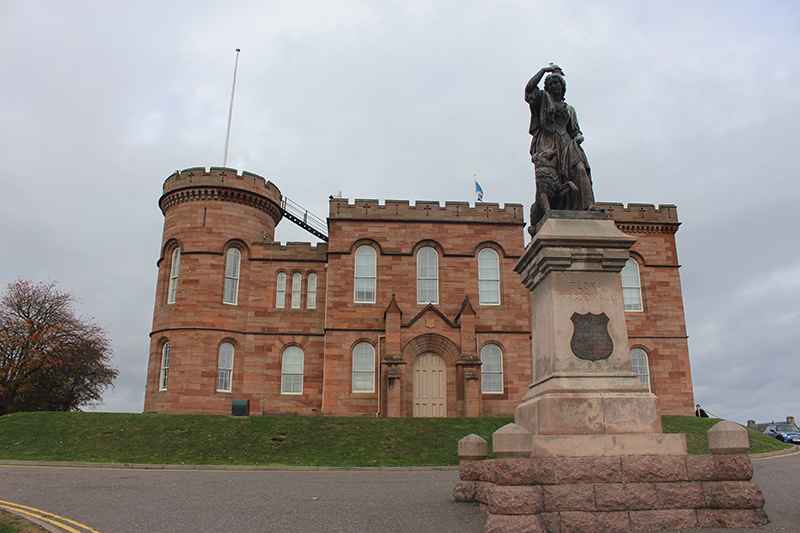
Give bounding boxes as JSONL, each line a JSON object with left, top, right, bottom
{"left": 0, "top": 0, "right": 800, "bottom": 422}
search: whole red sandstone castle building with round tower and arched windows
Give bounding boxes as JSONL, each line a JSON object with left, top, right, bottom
{"left": 144, "top": 168, "right": 694, "bottom": 417}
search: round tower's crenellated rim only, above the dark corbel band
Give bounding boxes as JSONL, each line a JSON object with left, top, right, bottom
{"left": 164, "top": 167, "right": 281, "bottom": 205}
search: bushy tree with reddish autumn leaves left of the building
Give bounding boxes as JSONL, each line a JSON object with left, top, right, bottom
{"left": 0, "top": 279, "right": 118, "bottom": 415}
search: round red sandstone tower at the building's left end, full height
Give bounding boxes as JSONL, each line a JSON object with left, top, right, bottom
{"left": 145, "top": 167, "right": 282, "bottom": 412}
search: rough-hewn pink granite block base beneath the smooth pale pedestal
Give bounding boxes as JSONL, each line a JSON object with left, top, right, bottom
{"left": 453, "top": 454, "right": 769, "bottom": 533}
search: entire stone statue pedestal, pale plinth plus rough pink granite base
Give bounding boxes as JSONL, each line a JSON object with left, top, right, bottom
{"left": 453, "top": 211, "right": 769, "bottom": 533}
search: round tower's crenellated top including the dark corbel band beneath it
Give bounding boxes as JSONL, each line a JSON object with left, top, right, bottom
{"left": 158, "top": 167, "right": 282, "bottom": 224}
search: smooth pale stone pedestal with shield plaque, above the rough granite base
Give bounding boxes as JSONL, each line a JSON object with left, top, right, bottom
{"left": 515, "top": 211, "right": 664, "bottom": 448}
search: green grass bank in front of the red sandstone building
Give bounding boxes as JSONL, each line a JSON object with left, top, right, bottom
{"left": 0, "top": 412, "right": 790, "bottom": 466}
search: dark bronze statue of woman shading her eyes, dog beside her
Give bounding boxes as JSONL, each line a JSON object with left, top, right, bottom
{"left": 525, "top": 63, "right": 602, "bottom": 233}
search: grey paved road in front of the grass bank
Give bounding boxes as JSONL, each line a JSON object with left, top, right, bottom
{"left": 0, "top": 454, "right": 800, "bottom": 533}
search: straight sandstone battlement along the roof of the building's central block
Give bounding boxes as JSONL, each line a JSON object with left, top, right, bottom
{"left": 329, "top": 198, "right": 525, "bottom": 225}
